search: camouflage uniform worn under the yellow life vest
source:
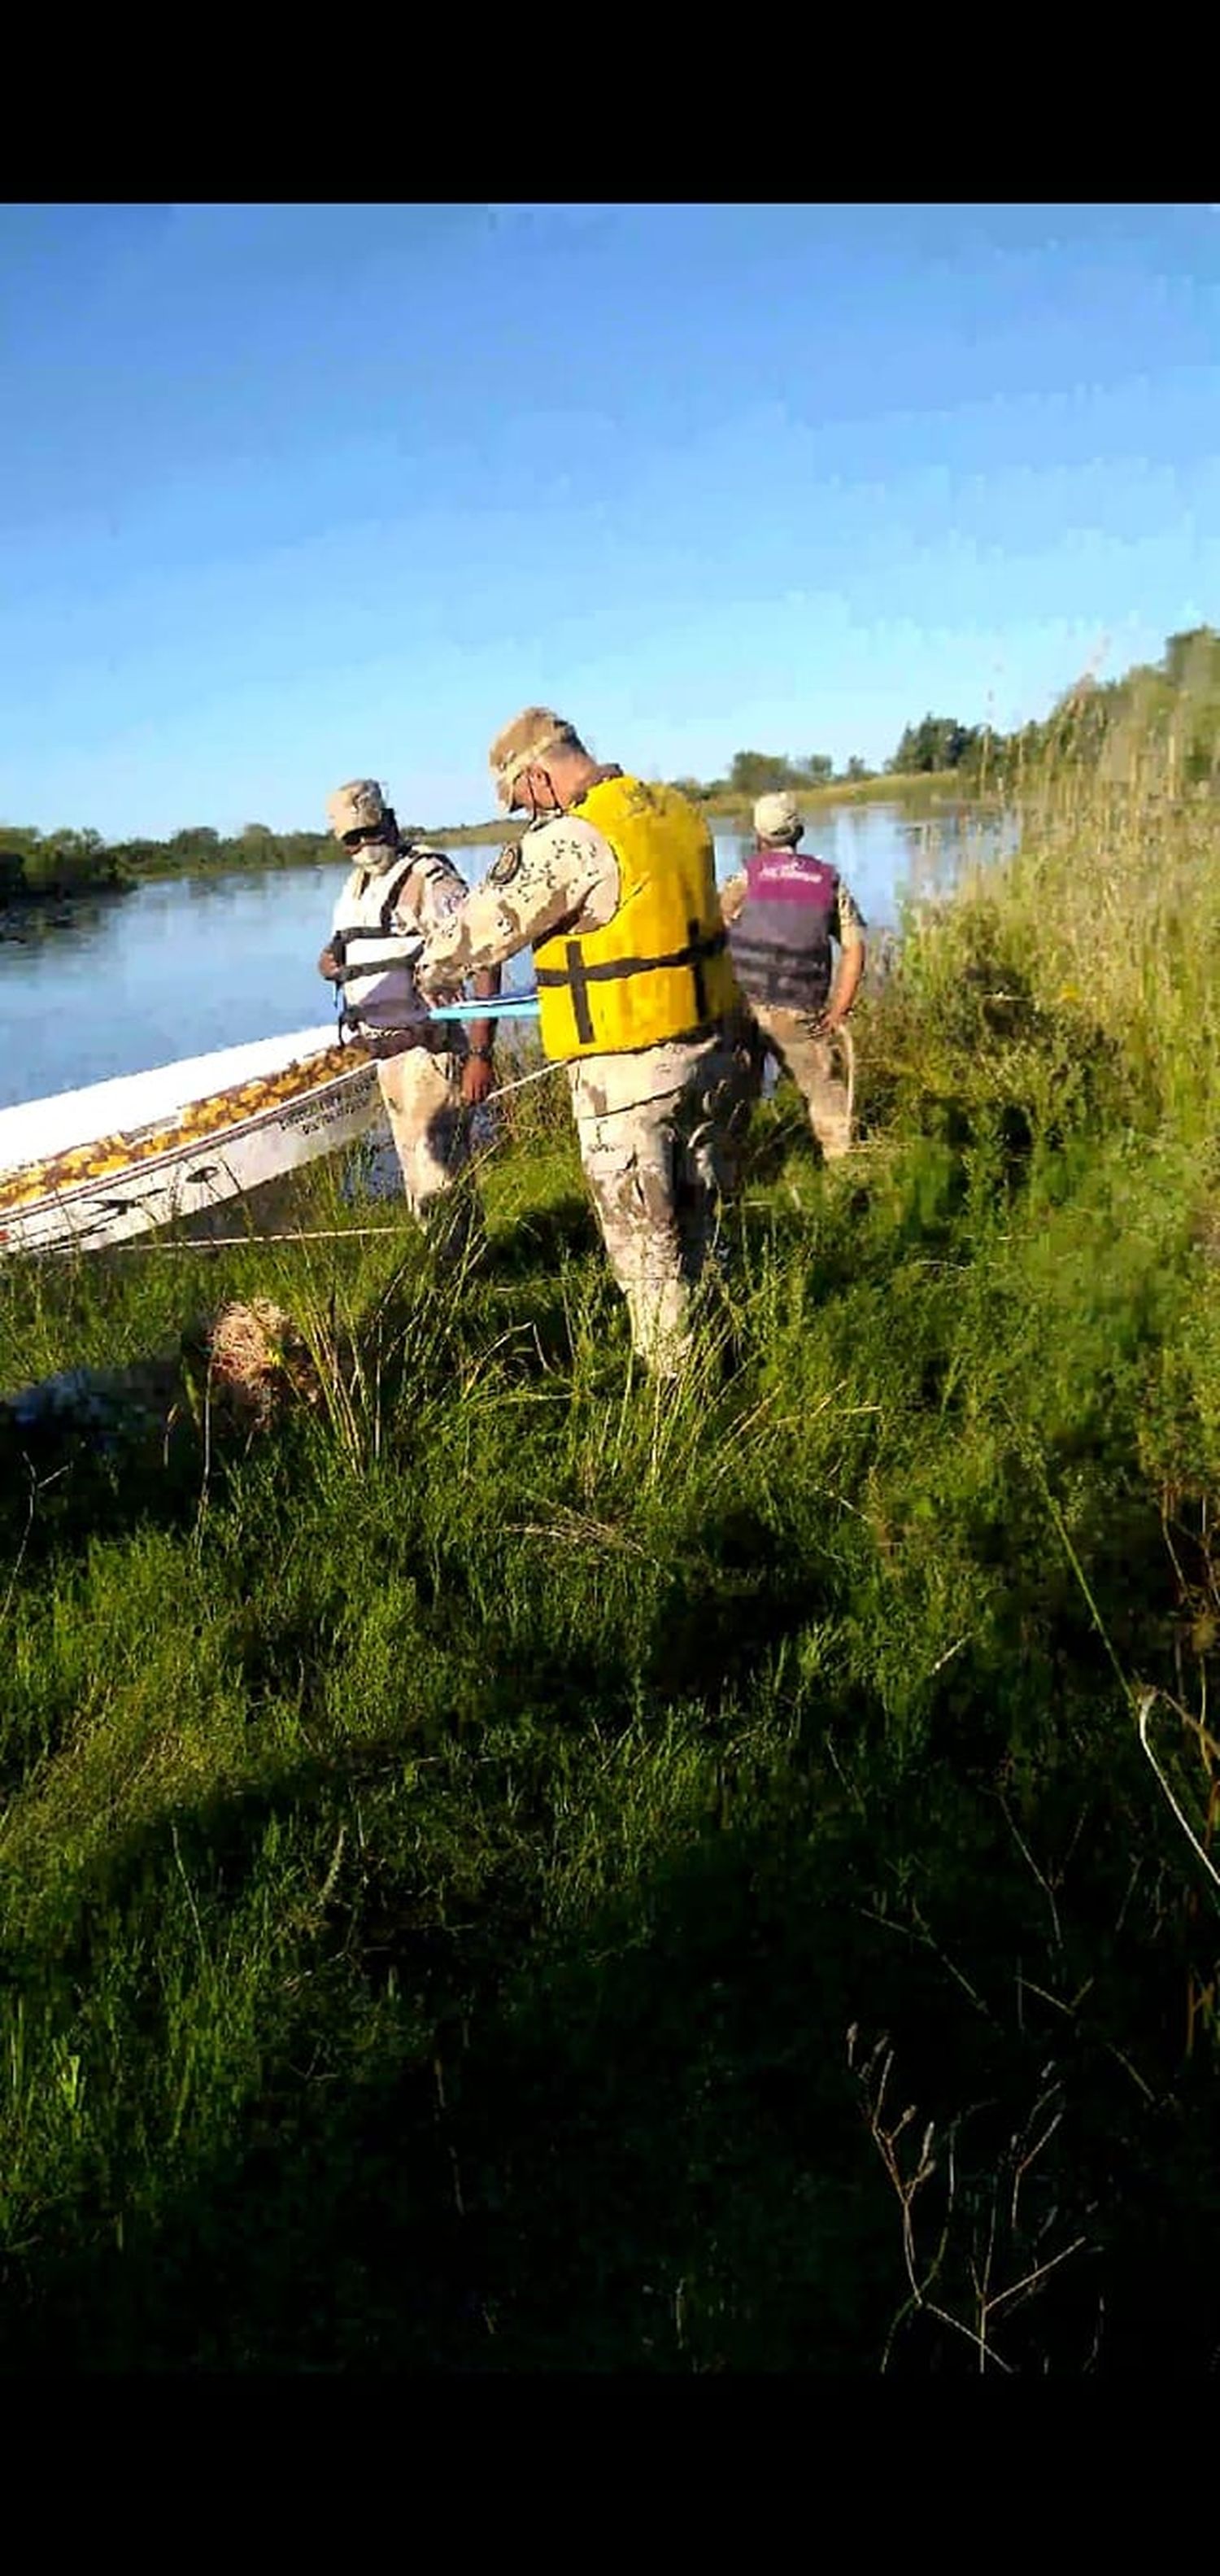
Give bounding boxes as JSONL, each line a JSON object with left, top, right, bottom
{"left": 420, "top": 814, "right": 747, "bottom": 1376}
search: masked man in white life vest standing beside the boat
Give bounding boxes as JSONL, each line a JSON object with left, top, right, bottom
{"left": 316, "top": 778, "right": 499, "bottom": 1252}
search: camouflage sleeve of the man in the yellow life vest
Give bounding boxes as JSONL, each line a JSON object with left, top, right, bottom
{"left": 417, "top": 824, "right": 617, "bottom": 992}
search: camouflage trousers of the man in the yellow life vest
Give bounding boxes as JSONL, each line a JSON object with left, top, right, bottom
{"left": 574, "top": 1041, "right": 749, "bottom": 1378}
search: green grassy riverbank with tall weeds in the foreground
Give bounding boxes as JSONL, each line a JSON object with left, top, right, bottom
{"left": 0, "top": 752, "right": 1220, "bottom": 2375}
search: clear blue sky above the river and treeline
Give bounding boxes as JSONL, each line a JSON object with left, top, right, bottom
{"left": 0, "top": 203, "right": 1220, "bottom": 837}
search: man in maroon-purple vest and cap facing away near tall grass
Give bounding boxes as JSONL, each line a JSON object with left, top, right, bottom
{"left": 721, "top": 791, "right": 867, "bottom": 1162}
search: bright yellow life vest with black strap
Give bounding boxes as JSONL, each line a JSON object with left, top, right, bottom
{"left": 533, "top": 778, "right": 739, "bottom": 1059}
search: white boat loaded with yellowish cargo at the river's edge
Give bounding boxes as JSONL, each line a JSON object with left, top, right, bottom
{"left": 0, "top": 1025, "right": 381, "bottom": 1257}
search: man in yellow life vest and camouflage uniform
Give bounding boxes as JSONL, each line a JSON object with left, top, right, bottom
{"left": 417, "top": 705, "right": 744, "bottom": 1376}
